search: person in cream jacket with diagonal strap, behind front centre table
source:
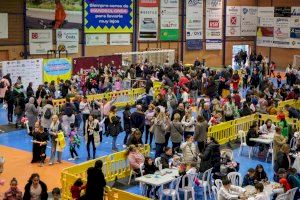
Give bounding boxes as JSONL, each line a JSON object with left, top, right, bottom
{"left": 180, "top": 135, "right": 198, "bottom": 164}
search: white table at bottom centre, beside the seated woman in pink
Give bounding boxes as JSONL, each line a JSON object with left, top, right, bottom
{"left": 135, "top": 168, "right": 179, "bottom": 187}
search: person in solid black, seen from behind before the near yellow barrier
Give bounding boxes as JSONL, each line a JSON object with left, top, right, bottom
{"left": 79, "top": 160, "right": 106, "bottom": 200}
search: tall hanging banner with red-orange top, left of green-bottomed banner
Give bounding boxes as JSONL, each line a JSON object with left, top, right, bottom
{"left": 139, "top": 0, "right": 158, "bottom": 41}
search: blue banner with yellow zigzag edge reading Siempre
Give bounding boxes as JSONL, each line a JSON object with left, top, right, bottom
{"left": 84, "top": 0, "right": 133, "bottom": 33}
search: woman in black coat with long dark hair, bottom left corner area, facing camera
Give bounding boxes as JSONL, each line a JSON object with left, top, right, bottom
{"left": 23, "top": 174, "right": 48, "bottom": 200}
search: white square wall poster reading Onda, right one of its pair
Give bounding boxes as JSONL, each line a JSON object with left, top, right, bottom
{"left": 56, "top": 29, "right": 79, "bottom": 54}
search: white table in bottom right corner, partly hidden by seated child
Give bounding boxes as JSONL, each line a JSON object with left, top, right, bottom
{"left": 244, "top": 182, "right": 284, "bottom": 200}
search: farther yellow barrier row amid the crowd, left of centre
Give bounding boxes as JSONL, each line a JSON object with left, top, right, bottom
{"left": 52, "top": 82, "right": 161, "bottom": 114}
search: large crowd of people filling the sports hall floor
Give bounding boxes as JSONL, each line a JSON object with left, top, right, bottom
{"left": 0, "top": 54, "right": 300, "bottom": 199}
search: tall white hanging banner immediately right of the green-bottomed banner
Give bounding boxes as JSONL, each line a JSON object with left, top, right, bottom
{"left": 186, "top": 0, "right": 203, "bottom": 40}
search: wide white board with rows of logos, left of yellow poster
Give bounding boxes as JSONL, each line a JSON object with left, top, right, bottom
{"left": 2, "top": 59, "right": 43, "bottom": 89}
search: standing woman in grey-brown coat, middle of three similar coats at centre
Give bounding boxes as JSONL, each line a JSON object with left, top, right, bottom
{"left": 170, "top": 113, "right": 184, "bottom": 152}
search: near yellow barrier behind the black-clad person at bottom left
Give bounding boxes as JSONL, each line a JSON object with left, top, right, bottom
{"left": 61, "top": 145, "right": 150, "bottom": 200}
